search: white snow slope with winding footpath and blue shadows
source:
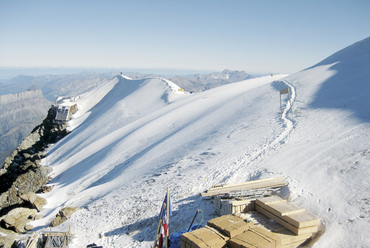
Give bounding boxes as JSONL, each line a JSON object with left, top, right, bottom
{"left": 32, "top": 39, "right": 370, "bottom": 247}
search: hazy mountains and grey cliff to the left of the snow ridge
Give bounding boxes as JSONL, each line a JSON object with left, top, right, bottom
{"left": 0, "top": 73, "right": 126, "bottom": 164}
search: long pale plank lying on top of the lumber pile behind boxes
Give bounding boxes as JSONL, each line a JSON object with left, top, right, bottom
{"left": 201, "top": 178, "right": 287, "bottom": 197}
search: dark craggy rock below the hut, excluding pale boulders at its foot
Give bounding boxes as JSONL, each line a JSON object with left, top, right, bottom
{"left": 0, "top": 107, "right": 68, "bottom": 216}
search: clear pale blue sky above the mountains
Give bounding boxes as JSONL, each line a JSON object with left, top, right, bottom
{"left": 0, "top": 0, "right": 370, "bottom": 74}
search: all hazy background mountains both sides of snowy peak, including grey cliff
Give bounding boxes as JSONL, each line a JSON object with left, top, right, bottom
{"left": 0, "top": 70, "right": 252, "bottom": 164}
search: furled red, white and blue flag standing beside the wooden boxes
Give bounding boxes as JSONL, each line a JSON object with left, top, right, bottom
{"left": 158, "top": 192, "right": 172, "bottom": 248}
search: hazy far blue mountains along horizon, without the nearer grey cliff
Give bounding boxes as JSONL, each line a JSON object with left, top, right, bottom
{"left": 0, "top": 70, "right": 253, "bottom": 101}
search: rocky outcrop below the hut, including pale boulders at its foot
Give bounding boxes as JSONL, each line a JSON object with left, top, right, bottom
{"left": 0, "top": 108, "right": 68, "bottom": 233}
